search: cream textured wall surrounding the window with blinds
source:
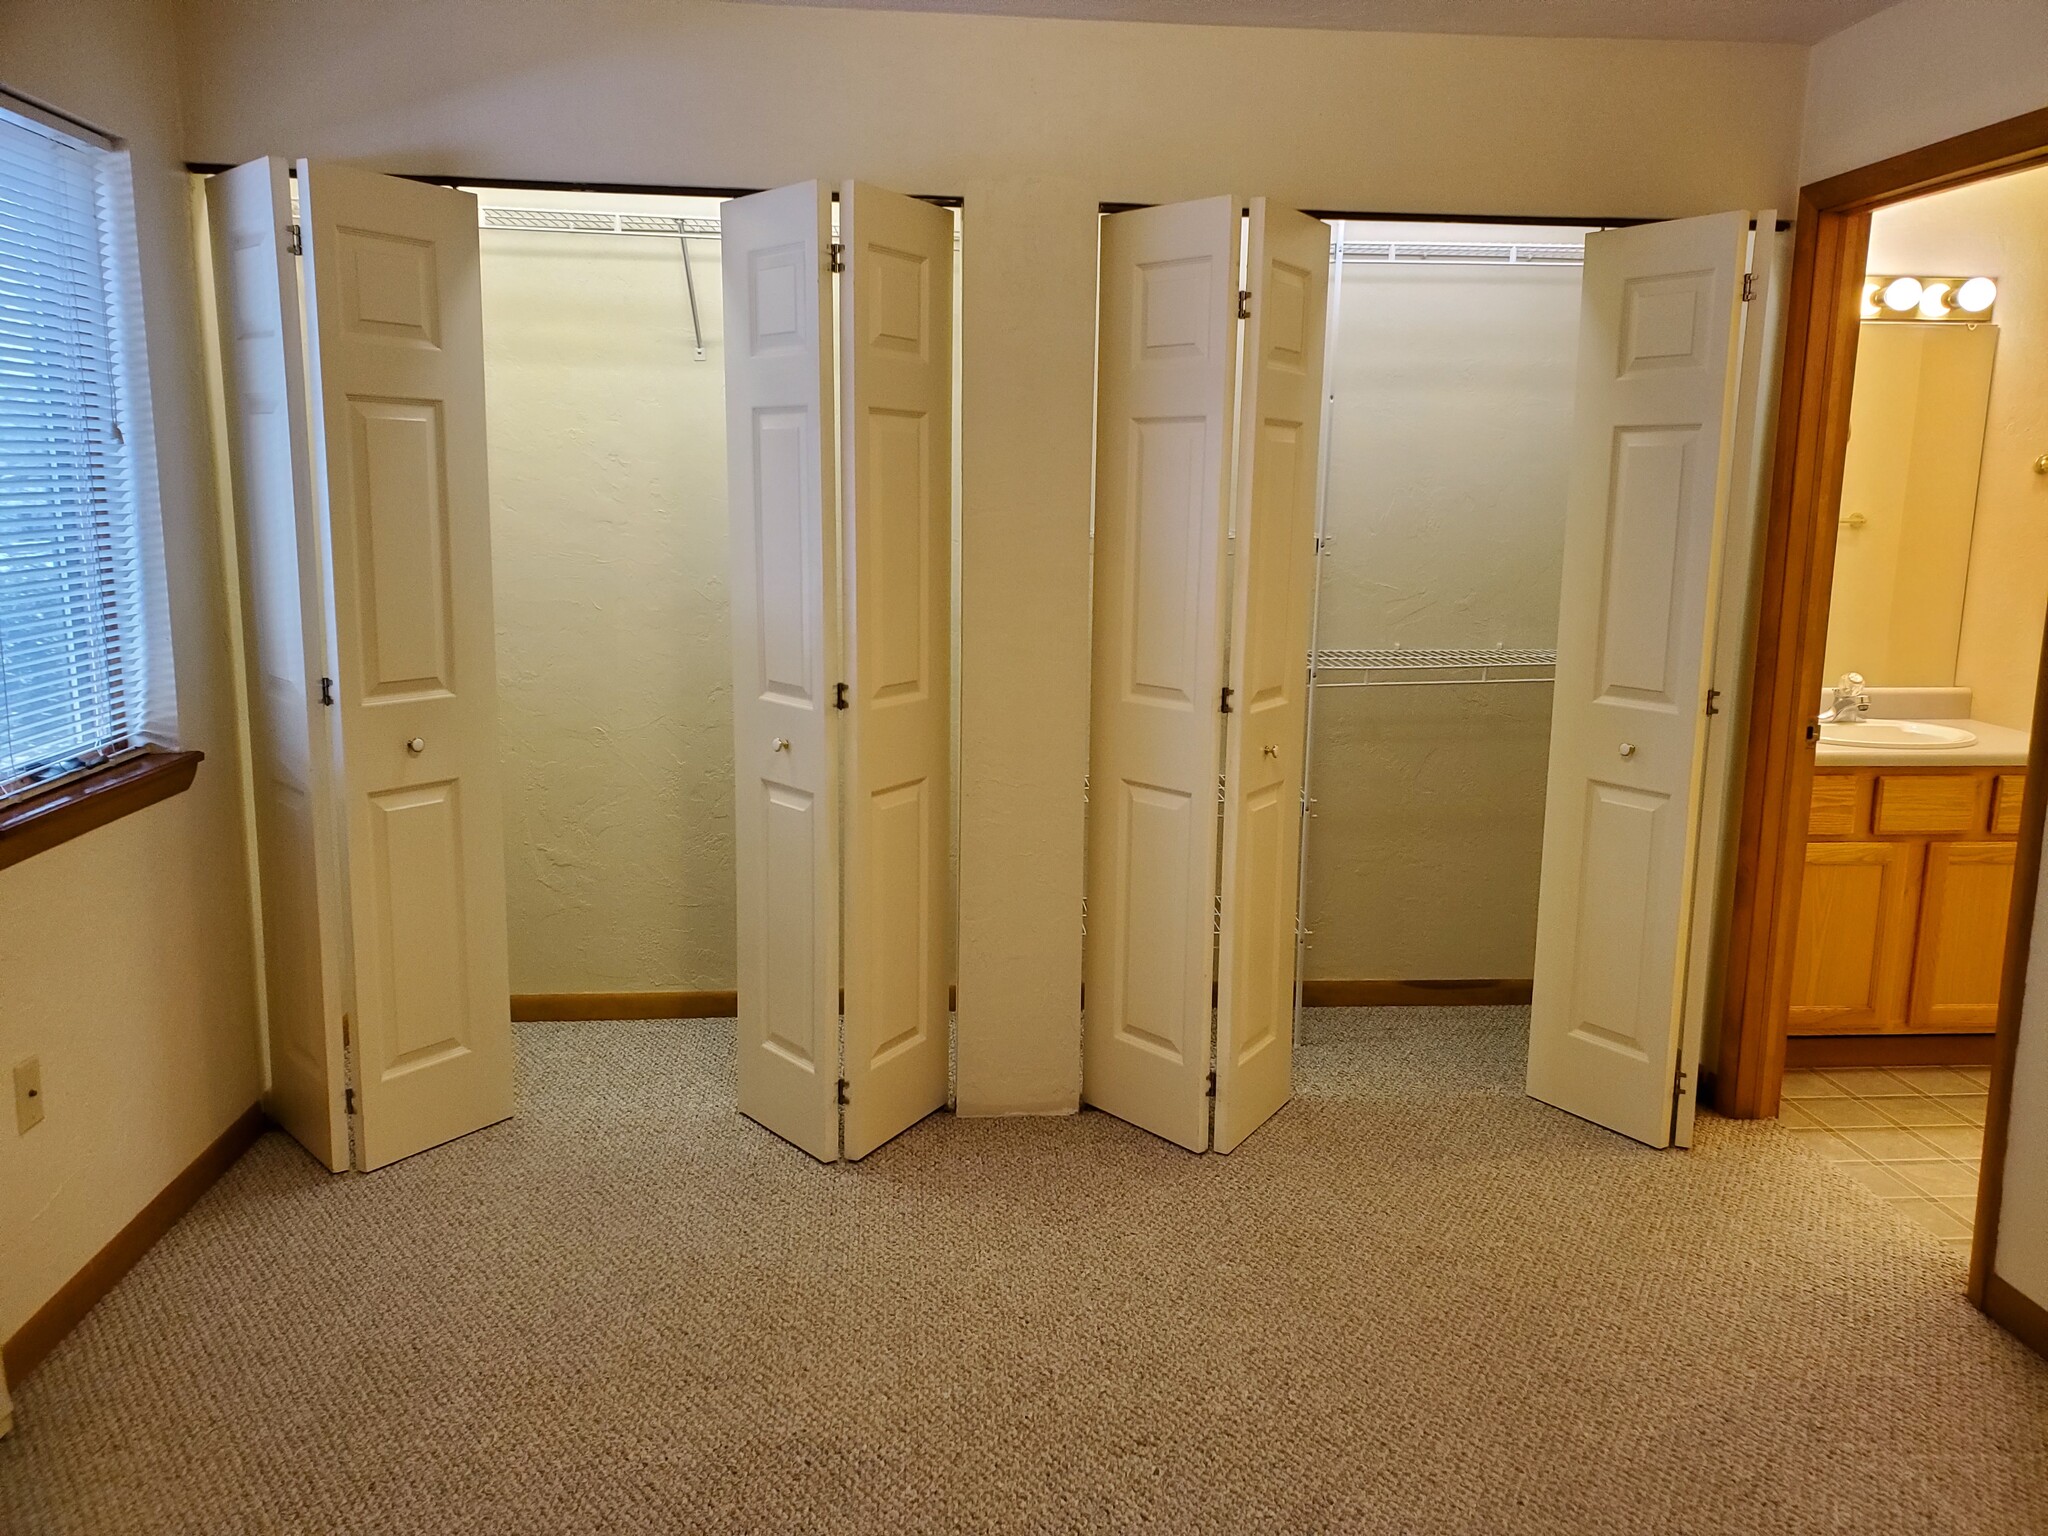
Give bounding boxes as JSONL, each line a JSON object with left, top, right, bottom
{"left": 0, "top": 0, "right": 262, "bottom": 1343}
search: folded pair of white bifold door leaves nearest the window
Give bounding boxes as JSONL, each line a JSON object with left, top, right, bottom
{"left": 209, "top": 162, "right": 512, "bottom": 1169}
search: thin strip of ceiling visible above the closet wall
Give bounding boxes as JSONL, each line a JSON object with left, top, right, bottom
{"left": 739, "top": 0, "right": 1894, "bottom": 43}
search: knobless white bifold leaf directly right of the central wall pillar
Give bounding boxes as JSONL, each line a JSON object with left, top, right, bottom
{"left": 1081, "top": 197, "right": 1236, "bottom": 1151}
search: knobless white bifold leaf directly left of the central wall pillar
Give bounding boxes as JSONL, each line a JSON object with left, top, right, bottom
{"left": 840, "top": 182, "right": 952, "bottom": 1157}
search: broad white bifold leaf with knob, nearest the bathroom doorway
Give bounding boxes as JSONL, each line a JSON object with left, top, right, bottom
{"left": 1528, "top": 213, "right": 1749, "bottom": 1147}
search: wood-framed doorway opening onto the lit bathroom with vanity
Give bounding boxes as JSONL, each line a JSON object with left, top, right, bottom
{"left": 1718, "top": 113, "right": 2048, "bottom": 1331}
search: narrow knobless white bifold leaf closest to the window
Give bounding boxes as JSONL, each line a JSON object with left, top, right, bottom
{"left": 207, "top": 160, "right": 348, "bottom": 1171}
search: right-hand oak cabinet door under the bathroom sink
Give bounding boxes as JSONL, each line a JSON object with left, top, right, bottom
{"left": 1911, "top": 842, "right": 2017, "bottom": 1030}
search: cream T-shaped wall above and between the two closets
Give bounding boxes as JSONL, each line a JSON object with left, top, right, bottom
{"left": 176, "top": 0, "right": 1806, "bottom": 1110}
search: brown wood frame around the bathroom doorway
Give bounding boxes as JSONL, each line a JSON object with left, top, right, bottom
{"left": 1714, "top": 109, "right": 2048, "bottom": 1305}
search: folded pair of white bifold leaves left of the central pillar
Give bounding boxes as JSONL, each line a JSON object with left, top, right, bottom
{"left": 723, "top": 182, "right": 952, "bottom": 1159}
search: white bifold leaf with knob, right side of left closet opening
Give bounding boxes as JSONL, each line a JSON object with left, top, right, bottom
{"left": 721, "top": 182, "right": 840, "bottom": 1161}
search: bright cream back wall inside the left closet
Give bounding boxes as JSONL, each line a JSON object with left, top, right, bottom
{"left": 481, "top": 193, "right": 733, "bottom": 993}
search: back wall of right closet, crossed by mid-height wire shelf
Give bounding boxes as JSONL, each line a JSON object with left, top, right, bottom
{"left": 1307, "top": 225, "right": 1579, "bottom": 979}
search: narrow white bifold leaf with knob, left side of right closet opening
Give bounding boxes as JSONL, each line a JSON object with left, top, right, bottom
{"left": 1214, "top": 199, "right": 1329, "bottom": 1151}
